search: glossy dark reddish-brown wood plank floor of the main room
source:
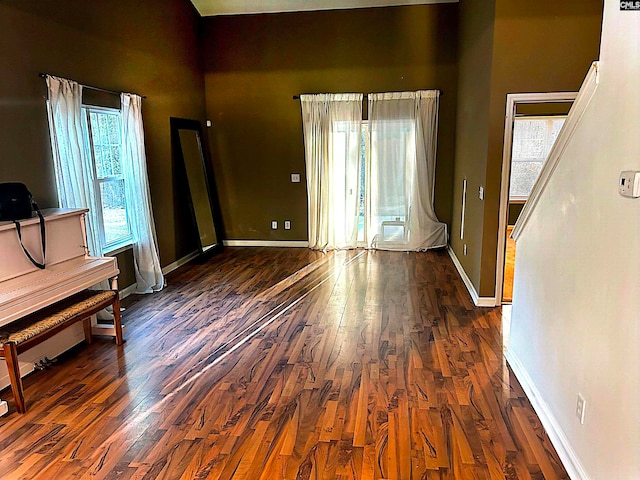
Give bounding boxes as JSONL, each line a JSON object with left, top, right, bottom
{"left": 0, "top": 248, "right": 568, "bottom": 480}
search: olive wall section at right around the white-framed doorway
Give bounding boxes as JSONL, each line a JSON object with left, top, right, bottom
{"left": 451, "top": 0, "right": 603, "bottom": 297}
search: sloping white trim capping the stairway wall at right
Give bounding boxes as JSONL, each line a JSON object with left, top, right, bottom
{"left": 511, "top": 62, "right": 600, "bottom": 241}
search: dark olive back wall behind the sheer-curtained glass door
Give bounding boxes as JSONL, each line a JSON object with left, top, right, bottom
{"left": 203, "top": 4, "right": 458, "bottom": 240}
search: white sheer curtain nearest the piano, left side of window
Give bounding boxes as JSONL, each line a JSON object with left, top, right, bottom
{"left": 46, "top": 75, "right": 103, "bottom": 257}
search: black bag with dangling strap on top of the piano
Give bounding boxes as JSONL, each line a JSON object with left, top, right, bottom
{"left": 0, "top": 182, "right": 47, "bottom": 269}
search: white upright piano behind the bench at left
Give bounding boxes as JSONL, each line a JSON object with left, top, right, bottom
{"left": 0, "top": 209, "right": 120, "bottom": 388}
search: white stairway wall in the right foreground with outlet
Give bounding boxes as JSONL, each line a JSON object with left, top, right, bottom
{"left": 507, "top": 0, "right": 640, "bottom": 480}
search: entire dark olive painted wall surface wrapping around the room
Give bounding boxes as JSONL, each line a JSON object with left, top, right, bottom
{"left": 0, "top": 0, "right": 602, "bottom": 296}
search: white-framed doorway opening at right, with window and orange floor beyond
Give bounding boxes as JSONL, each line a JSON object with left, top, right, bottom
{"left": 496, "top": 92, "right": 577, "bottom": 304}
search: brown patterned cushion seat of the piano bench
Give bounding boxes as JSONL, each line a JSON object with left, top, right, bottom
{"left": 0, "top": 290, "right": 116, "bottom": 348}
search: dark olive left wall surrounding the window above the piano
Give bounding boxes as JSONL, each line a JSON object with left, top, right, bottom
{"left": 0, "top": 0, "right": 205, "bottom": 286}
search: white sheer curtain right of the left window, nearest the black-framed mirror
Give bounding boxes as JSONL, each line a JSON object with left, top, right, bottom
{"left": 120, "top": 93, "right": 164, "bottom": 293}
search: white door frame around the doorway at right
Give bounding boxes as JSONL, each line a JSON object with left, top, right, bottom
{"left": 495, "top": 92, "right": 578, "bottom": 306}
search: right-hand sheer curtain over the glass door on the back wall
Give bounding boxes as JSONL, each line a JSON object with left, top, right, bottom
{"left": 365, "top": 90, "right": 447, "bottom": 251}
